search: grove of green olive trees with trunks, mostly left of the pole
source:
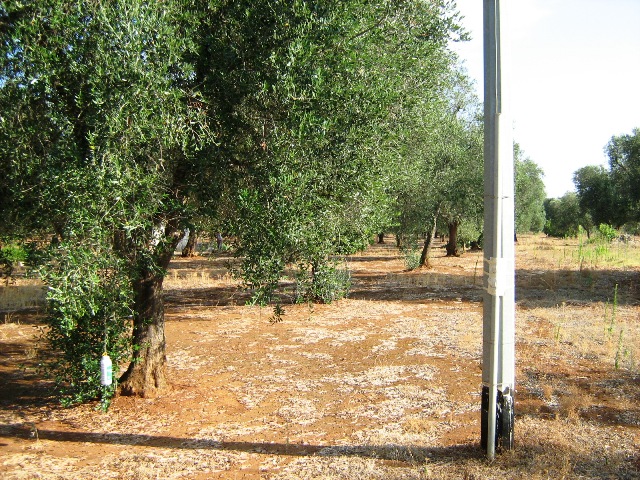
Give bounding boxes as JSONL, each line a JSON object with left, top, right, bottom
{"left": 0, "top": 0, "right": 544, "bottom": 404}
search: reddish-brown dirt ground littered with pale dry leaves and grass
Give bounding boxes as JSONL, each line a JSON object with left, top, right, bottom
{"left": 0, "top": 236, "right": 640, "bottom": 479}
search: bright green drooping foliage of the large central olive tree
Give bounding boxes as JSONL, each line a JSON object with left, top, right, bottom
{"left": 224, "top": 1, "right": 460, "bottom": 302}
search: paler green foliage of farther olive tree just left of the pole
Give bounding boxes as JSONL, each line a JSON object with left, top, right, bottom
{"left": 388, "top": 66, "right": 483, "bottom": 263}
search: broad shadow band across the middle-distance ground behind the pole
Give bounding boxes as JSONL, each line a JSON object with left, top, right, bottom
{"left": 165, "top": 257, "right": 640, "bottom": 308}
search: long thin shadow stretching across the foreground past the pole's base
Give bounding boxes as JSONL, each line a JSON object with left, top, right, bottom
{"left": 0, "top": 424, "right": 640, "bottom": 478}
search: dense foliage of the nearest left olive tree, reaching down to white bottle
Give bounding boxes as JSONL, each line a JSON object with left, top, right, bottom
{"left": 0, "top": 0, "right": 214, "bottom": 401}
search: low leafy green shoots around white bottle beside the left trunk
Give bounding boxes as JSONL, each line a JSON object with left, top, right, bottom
{"left": 40, "top": 242, "right": 132, "bottom": 407}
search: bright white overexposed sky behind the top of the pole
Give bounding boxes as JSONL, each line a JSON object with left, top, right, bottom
{"left": 454, "top": 0, "right": 640, "bottom": 197}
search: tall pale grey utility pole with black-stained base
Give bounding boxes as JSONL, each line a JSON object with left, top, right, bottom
{"left": 481, "top": 0, "right": 515, "bottom": 460}
